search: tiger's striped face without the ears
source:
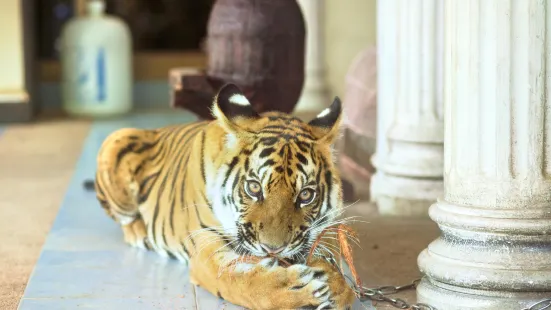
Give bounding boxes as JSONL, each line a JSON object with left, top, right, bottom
{"left": 230, "top": 133, "right": 341, "bottom": 258}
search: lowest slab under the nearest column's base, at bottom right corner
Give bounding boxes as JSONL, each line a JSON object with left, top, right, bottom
{"left": 417, "top": 277, "right": 551, "bottom": 310}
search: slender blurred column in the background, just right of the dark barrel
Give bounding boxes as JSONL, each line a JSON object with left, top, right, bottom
{"left": 295, "top": 0, "right": 331, "bottom": 112}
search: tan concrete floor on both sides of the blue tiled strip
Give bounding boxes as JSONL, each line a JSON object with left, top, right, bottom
{"left": 0, "top": 108, "right": 438, "bottom": 309}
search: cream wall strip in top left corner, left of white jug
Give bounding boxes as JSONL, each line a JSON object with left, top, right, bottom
{"left": 0, "top": 0, "right": 25, "bottom": 95}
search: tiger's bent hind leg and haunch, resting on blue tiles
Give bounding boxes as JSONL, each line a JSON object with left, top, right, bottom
{"left": 95, "top": 129, "right": 156, "bottom": 249}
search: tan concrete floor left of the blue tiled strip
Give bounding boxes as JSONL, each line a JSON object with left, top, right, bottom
{"left": 0, "top": 116, "right": 90, "bottom": 309}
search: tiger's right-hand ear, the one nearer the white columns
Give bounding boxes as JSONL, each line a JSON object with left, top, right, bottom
{"left": 308, "top": 97, "right": 342, "bottom": 144}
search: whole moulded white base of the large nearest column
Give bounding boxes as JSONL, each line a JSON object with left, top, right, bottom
{"left": 417, "top": 200, "right": 551, "bottom": 310}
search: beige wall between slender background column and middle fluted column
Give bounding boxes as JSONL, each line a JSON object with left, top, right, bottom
{"left": 326, "top": 0, "right": 377, "bottom": 98}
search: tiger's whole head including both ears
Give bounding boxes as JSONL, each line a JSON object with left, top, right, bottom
{"left": 210, "top": 85, "right": 342, "bottom": 260}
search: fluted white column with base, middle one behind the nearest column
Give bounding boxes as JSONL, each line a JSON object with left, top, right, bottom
{"left": 372, "top": 0, "right": 443, "bottom": 216}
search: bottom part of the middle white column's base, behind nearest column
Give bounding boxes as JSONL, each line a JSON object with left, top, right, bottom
{"left": 371, "top": 172, "right": 444, "bottom": 218}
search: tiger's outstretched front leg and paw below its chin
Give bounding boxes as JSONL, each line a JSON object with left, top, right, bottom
{"left": 191, "top": 258, "right": 354, "bottom": 310}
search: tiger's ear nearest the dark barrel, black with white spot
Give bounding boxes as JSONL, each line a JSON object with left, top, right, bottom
{"left": 212, "top": 83, "right": 260, "bottom": 133}
